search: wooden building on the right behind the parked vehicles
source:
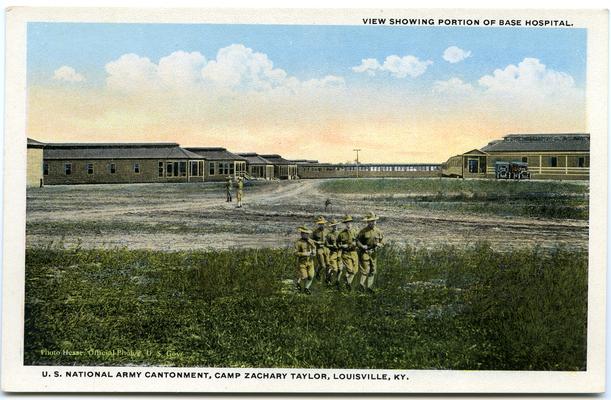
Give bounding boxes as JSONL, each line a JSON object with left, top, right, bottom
{"left": 443, "top": 133, "right": 590, "bottom": 179}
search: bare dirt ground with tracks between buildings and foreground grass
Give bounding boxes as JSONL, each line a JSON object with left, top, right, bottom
{"left": 26, "top": 180, "right": 588, "bottom": 250}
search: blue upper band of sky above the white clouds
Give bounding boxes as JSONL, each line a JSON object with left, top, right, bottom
{"left": 28, "top": 23, "right": 586, "bottom": 87}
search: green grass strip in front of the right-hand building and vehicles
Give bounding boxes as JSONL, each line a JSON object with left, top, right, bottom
{"left": 321, "top": 179, "right": 589, "bottom": 220}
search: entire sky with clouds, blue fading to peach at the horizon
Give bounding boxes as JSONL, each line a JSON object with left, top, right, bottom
{"left": 27, "top": 23, "right": 587, "bottom": 162}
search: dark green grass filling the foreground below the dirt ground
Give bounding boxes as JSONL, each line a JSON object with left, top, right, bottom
{"left": 25, "top": 244, "right": 587, "bottom": 370}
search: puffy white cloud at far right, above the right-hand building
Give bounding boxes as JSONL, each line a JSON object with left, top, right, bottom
{"left": 478, "top": 58, "right": 576, "bottom": 97}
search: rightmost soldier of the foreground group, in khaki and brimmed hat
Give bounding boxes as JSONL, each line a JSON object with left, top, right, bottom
{"left": 356, "top": 212, "right": 384, "bottom": 293}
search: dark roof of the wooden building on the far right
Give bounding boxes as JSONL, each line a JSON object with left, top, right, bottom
{"left": 481, "top": 133, "right": 590, "bottom": 153}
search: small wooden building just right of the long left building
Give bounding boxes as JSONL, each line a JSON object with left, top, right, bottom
{"left": 185, "top": 147, "right": 246, "bottom": 181}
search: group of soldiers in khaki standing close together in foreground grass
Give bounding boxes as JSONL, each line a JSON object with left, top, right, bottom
{"left": 295, "top": 212, "right": 384, "bottom": 294}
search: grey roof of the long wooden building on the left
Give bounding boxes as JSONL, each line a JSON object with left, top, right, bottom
{"left": 43, "top": 143, "right": 203, "bottom": 160}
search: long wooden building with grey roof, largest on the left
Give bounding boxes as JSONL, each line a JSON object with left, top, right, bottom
{"left": 43, "top": 143, "right": 205, "bottom": 185}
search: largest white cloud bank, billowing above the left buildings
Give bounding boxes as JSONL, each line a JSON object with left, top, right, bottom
{"left": 106, "top": 44, "right": 345, "bottom": 93}
